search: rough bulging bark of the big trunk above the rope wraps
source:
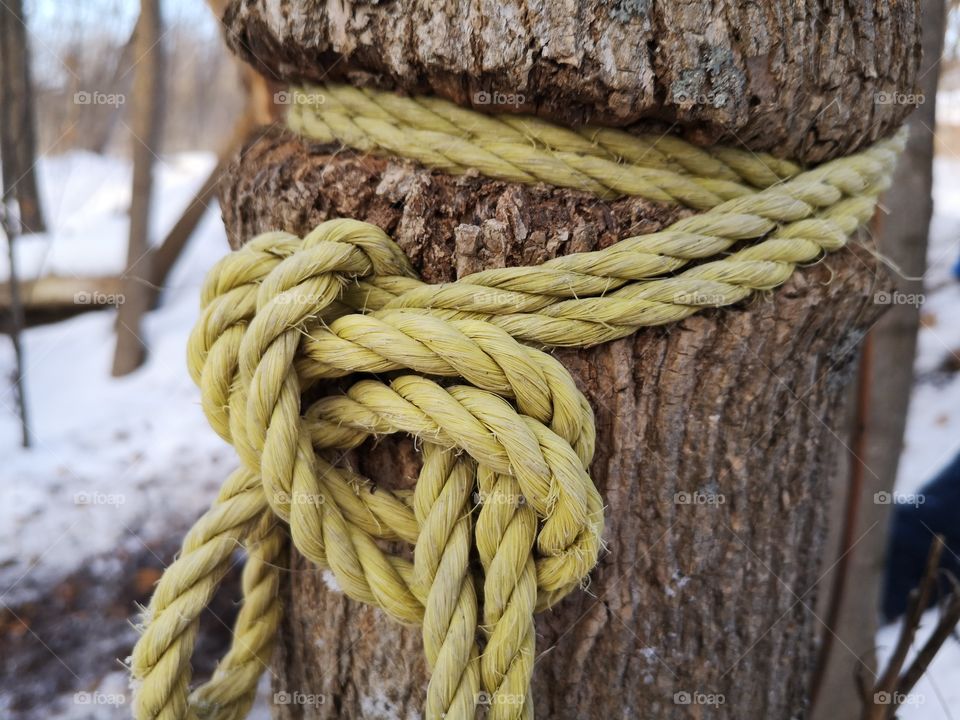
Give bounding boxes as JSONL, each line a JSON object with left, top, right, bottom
{"left": 224, "top": 0, "right": 921, "bottom": 161}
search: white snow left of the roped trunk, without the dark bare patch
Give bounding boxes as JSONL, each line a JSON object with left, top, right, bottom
{"left": 0, "top": 153, "right": 232, "bottom": 604}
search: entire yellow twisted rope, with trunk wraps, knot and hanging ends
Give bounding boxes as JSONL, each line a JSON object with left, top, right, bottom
{"left": 132, "top": 85, "right": 905, "bottom": 720}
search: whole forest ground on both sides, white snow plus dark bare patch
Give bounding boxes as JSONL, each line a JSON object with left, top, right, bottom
{"left": 0, "top": 153, "right": 960, "bottom": 720}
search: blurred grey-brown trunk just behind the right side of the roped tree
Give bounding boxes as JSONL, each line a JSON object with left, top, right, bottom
{"left": 814, "top": 0, "right": 945, "bottom": 720}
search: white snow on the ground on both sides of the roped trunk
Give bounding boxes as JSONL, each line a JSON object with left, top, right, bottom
{"left": 0, "top": 145, "right": 960, "bottom": 720}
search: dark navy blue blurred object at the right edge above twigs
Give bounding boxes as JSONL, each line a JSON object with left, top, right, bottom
{"left": 881, "top": 452, "right": 960, "bottom": 622}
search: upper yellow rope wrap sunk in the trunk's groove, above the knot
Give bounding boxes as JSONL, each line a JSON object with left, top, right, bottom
{"left": 287, "top": 84, "right": 798, "bottom": 202}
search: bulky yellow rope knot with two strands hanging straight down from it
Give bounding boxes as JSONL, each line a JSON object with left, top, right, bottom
{"left": 143, "top": 220, "right": 603, "bottom": 717}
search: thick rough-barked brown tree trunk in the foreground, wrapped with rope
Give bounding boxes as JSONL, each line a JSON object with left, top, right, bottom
{"left": 212, "top": 0, "right": 919, "bottom": 720}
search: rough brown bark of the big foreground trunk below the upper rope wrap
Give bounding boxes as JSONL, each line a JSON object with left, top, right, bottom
{"left": 222, "top": 133, "right": 892, "bottom": 720}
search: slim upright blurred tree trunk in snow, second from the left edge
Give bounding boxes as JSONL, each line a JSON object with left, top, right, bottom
{"left": 113, "top": 0, "right": 163, "bottom": 376}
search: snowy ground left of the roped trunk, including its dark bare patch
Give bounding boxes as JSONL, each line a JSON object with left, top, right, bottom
{"left": 0, "top": 152, "right": 264, "bottom": 720}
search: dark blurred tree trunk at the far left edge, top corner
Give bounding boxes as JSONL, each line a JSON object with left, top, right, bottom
{"left": 0, "top": 0, "right": 47, "bottom": 234}
